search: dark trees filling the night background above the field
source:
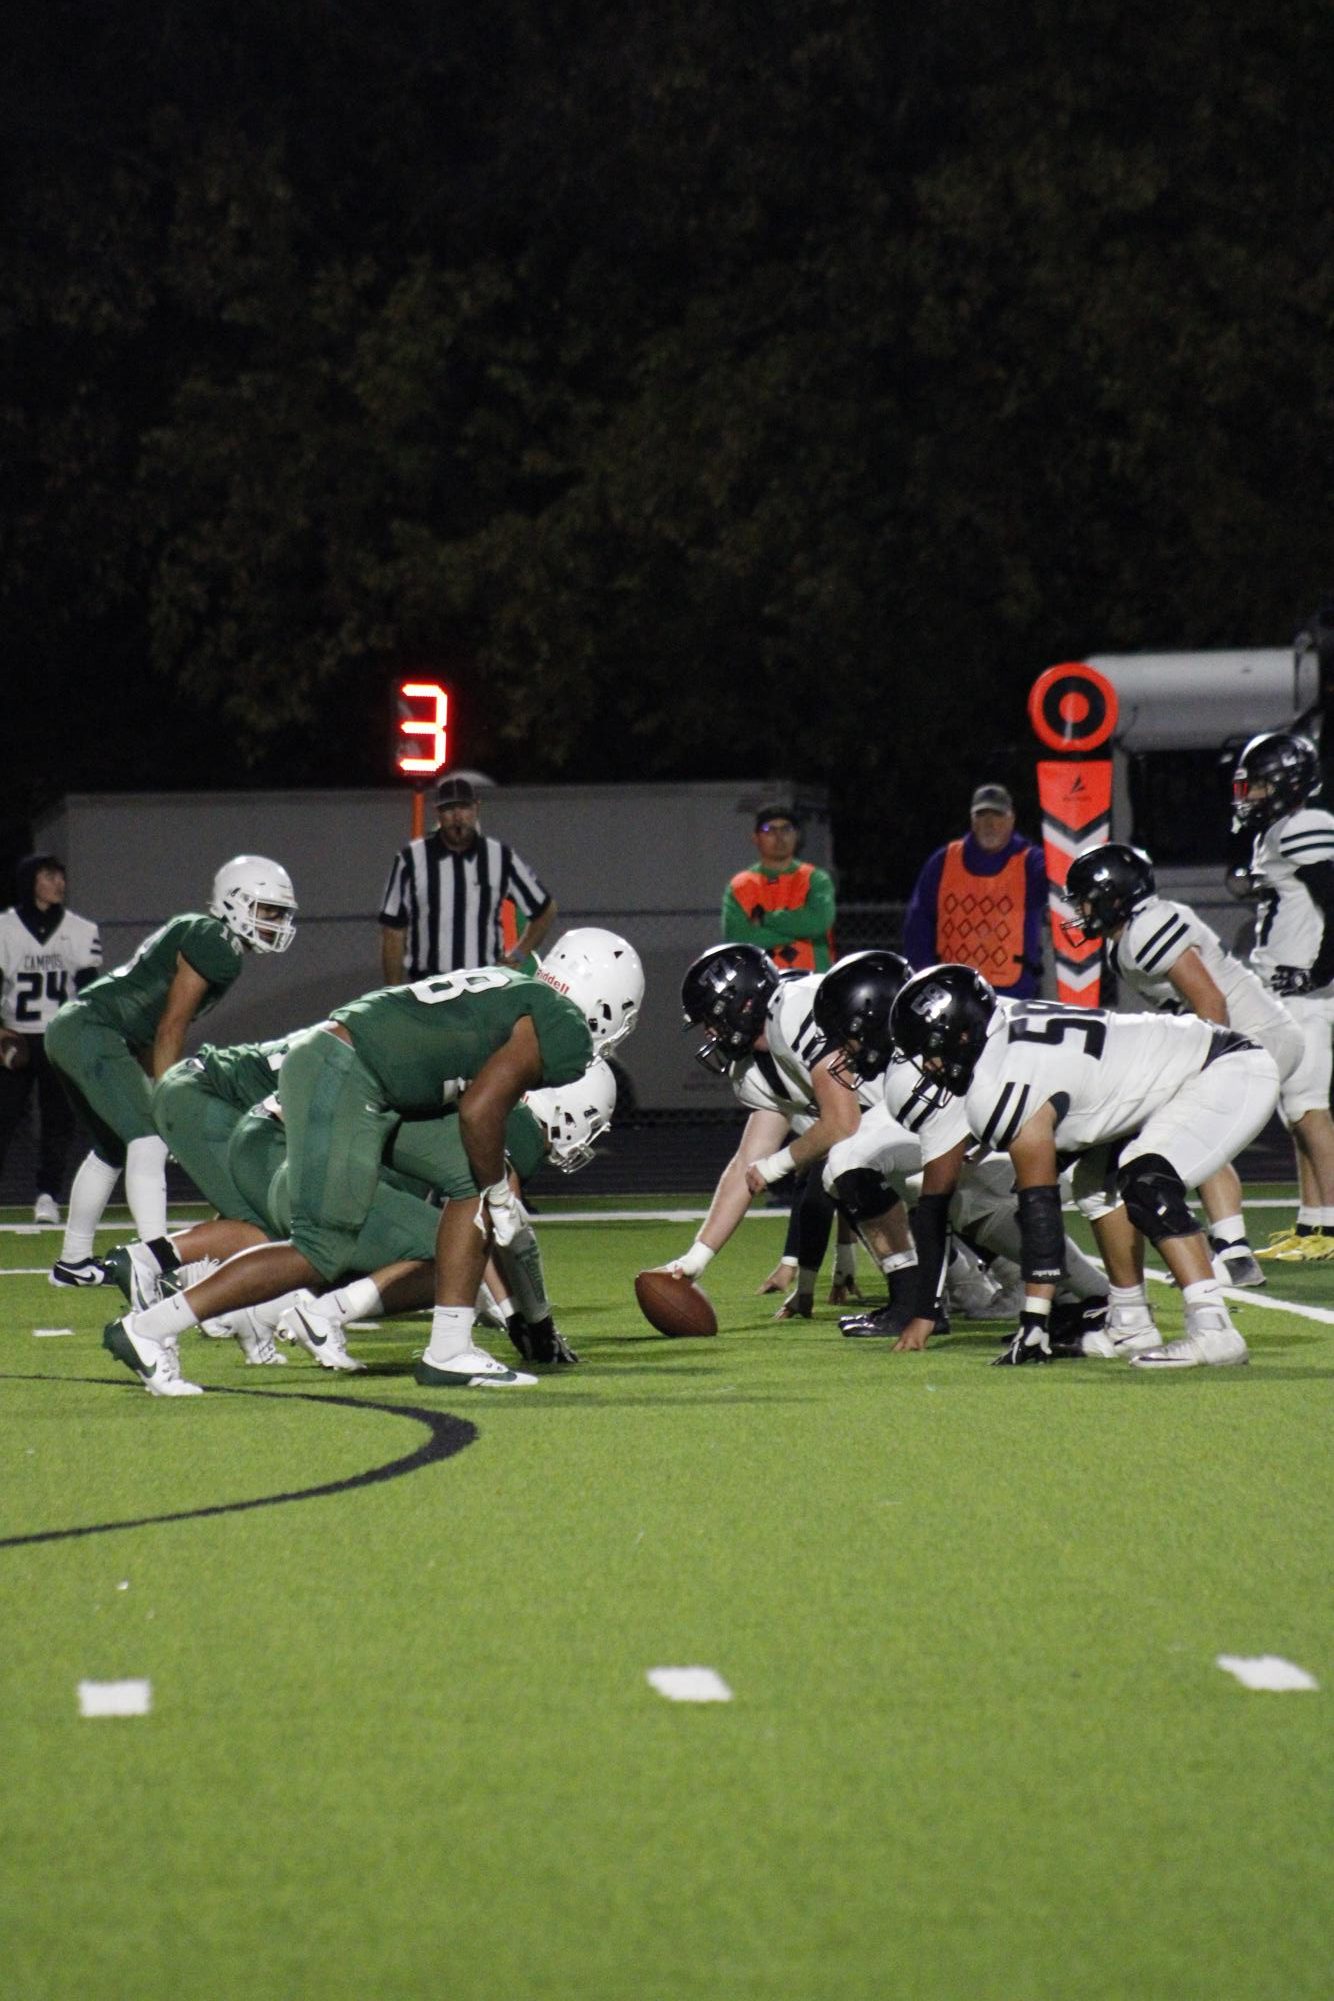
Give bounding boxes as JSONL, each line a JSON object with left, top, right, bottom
{"left": 0, "top": 0, "right": 1334, "bottom": 892}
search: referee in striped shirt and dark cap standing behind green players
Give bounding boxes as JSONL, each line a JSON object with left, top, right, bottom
{"left": 380, "top": 778, "right": 556, "bottom": 986}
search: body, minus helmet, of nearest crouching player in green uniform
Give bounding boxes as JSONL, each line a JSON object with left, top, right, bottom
{"left": 102, "top": 966, "right": 594, "bottom": 1397}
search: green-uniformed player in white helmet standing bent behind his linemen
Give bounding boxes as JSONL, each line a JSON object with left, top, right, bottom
{"left": 46, "top": 854, "right": 296, "bottom": 1285}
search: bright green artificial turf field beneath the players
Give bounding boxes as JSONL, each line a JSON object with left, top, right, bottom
{"left": 0, "top": 1199, "right": 1334, "bottom": 2001}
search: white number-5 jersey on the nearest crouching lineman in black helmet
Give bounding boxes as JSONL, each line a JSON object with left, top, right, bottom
{"left": 964, "top": 1001, "right": 1220, "bottom": 1153}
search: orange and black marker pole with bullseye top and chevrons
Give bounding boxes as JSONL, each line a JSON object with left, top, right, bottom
{"left": 1028, "top": 660, "right": 1116, "bottom": 1007}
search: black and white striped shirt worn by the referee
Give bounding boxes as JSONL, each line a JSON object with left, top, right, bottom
{"left": 380, "top": 834, "right": 552, "bottom": 980}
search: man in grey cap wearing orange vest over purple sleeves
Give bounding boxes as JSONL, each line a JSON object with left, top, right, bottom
{"left": 904, "top": 784, "right": 1046, "bottom": 1001}
